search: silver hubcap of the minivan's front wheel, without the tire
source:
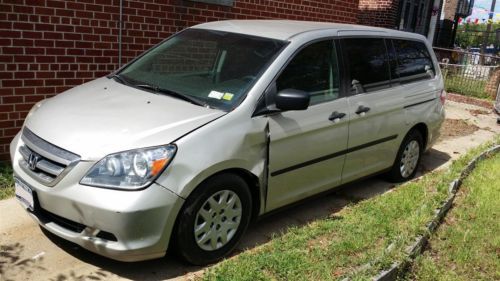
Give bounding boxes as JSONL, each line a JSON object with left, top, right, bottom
{"left": 194, "top": 190, "right": 243, "bottom": 251}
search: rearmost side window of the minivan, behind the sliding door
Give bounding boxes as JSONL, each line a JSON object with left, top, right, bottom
{"left": 391, "top": 39, "right": 434, "bottom": 83}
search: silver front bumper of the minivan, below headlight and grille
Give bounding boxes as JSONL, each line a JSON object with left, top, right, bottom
{"left": 11, "top": 132, "right": 183, "bottom": 261}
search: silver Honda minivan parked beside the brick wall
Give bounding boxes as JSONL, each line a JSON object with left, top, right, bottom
{"left": 10, "top": 20, "right": 445, "bottom": 264}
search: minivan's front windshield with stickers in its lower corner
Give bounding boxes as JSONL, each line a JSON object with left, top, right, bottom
{"left": 119, "top": 29, "right": 284, "bottom": 111}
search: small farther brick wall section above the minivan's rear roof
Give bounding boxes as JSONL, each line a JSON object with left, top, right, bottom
{"left": 358, "top": 0, "right": 399, "bottom": 28}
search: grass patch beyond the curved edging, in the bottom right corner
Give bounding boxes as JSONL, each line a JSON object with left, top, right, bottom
{"left": 408, "top": 154, "right": 500, "bottom": 280}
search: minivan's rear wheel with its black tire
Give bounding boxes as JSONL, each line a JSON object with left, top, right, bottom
{"left": 388, "top": 130, "right": 424, "bottom": 182}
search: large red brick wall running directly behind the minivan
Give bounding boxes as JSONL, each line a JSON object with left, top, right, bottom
{"left": 0, "top": 0, "right": 358, "bottom": 160}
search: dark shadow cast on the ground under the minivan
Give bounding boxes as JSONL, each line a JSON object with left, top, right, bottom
{"left": 43, "top": 149, "right": 450, "bottom": 280}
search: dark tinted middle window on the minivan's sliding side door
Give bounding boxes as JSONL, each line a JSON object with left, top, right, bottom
{"left": 342, "top": 38, "right": 391, "bottom": 93}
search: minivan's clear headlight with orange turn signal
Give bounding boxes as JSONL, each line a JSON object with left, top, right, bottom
{"left": 80, "top": 144, "right": 177, "bottom": 190}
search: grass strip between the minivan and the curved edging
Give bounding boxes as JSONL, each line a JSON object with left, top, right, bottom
{"left": 202, "top": 141, "right": 498, "bottom": 280}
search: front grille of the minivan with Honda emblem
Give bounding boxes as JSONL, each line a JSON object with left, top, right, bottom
{"left": 19, "top": 128, "right": 80, "bottom": 186}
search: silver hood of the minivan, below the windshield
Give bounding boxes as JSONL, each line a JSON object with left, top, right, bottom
{"left": 25, "top": 77, "right": 225, "bottom": 160}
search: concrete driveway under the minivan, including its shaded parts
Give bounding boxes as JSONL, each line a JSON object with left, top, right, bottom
{"left": 0, "top": 101, "right": 500, "bottom": 281}
